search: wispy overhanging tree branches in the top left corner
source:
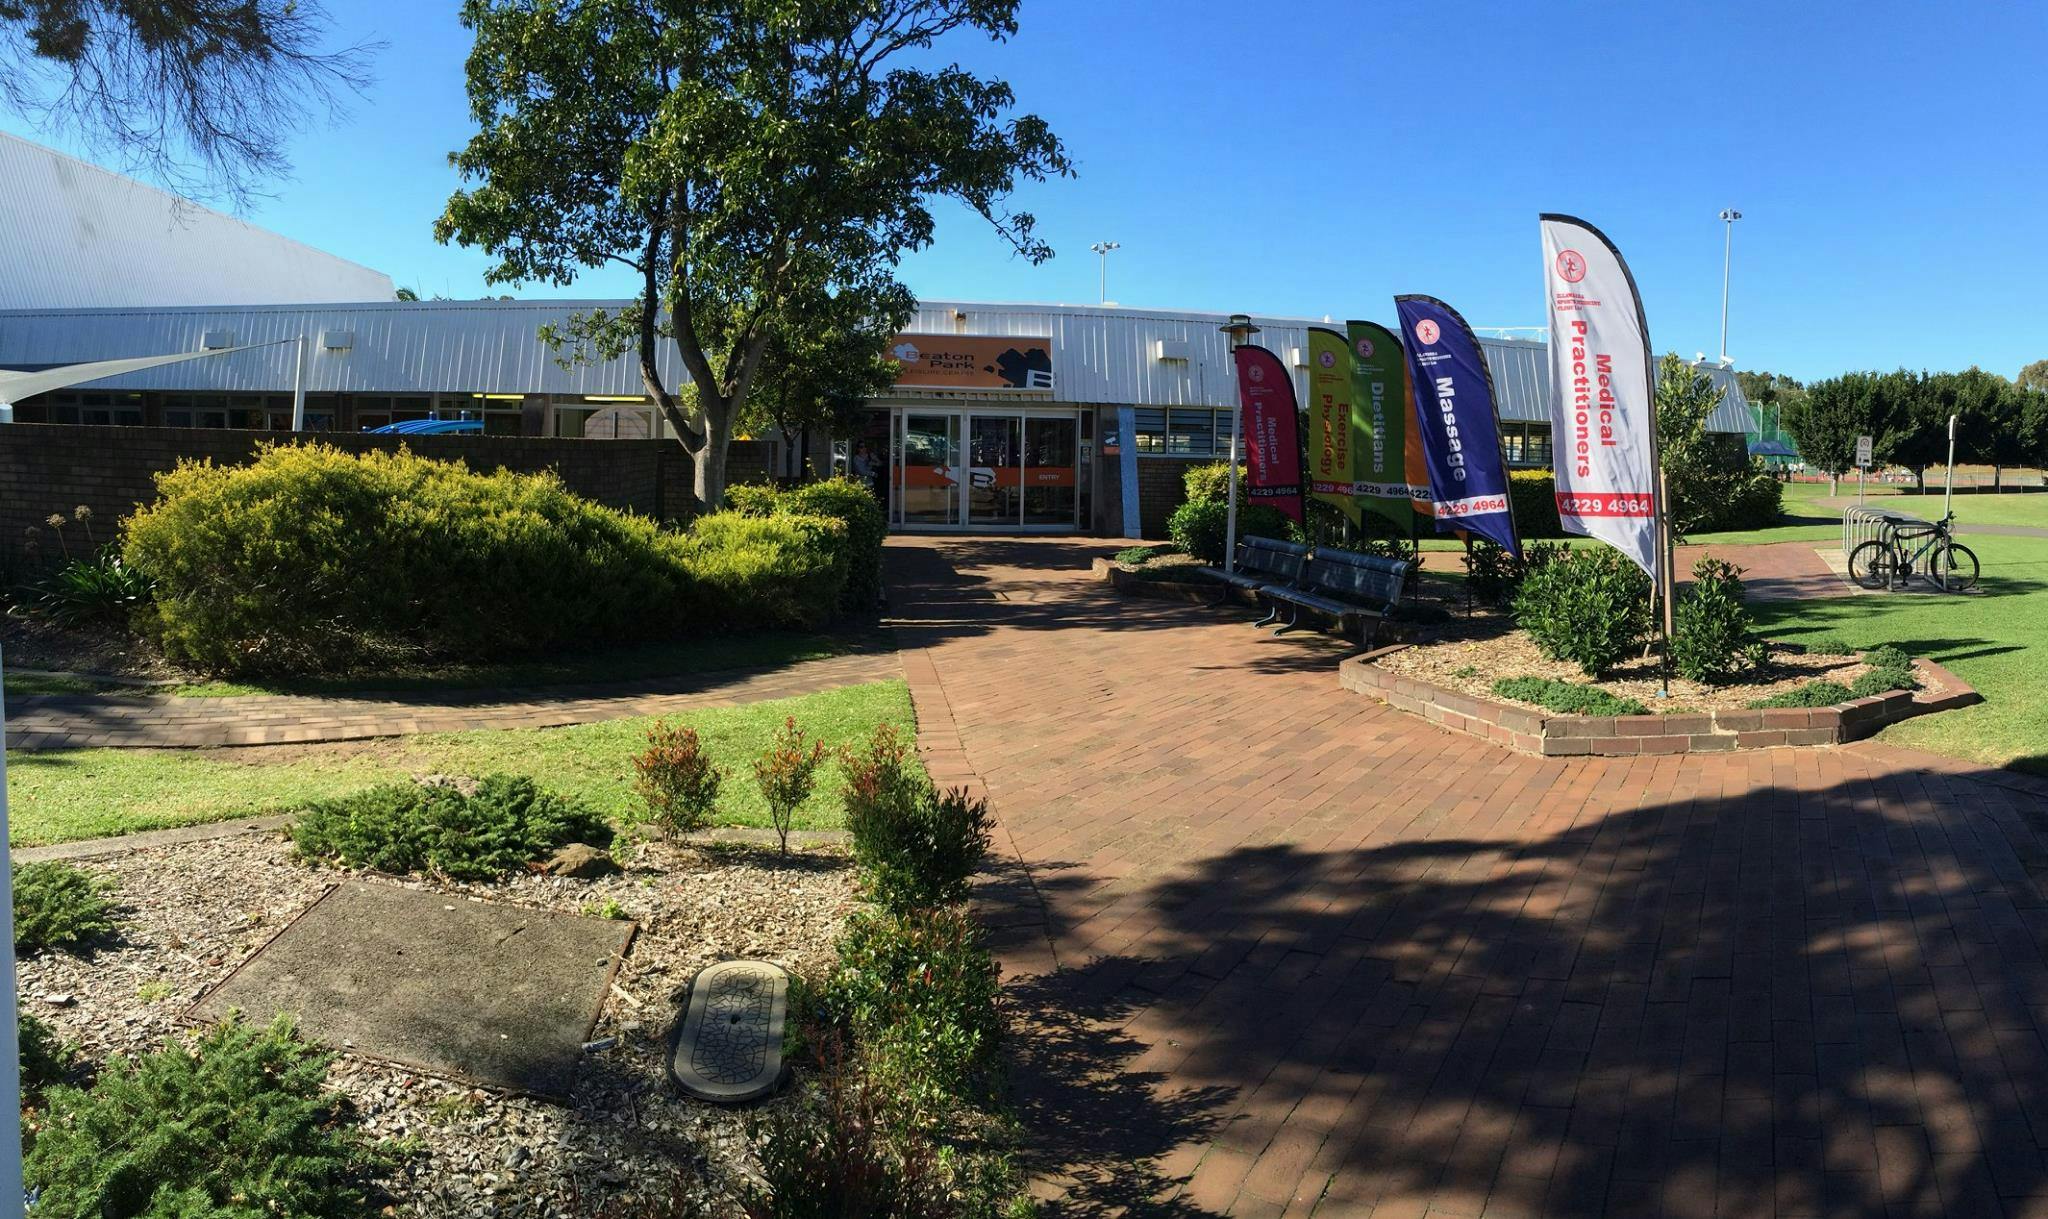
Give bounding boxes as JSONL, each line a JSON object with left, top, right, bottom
{"left": 0, "top": 0, "right": 377, "bottom": 203}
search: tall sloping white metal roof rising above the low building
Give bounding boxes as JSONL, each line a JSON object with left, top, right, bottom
{"left": 0, "top": 131, "right": 391, "bottom": 309}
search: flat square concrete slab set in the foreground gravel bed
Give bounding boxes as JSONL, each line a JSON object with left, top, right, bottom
{"left": 193, "top": 881, "right": 635, "bottom": 1100}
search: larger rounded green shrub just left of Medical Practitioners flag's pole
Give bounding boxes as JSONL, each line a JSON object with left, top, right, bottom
{"left": 1516, "top": 547, "right": 1651, "bottom": 676}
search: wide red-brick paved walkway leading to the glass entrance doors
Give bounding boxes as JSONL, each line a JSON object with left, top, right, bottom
{"left": 891, "top": 539, "right": 2048, "bottom": 1219}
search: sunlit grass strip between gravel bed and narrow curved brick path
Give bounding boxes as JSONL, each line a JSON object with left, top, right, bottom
{"left": 8, "top": 682, "right": 915, "bottom": 846}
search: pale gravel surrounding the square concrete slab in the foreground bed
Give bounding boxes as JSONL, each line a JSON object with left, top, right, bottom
{"left": 20, "top": 836, "right": 854, "bottom": 1215}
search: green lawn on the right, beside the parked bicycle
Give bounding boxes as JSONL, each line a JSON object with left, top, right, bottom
{"left": 1757, "top": 537, "right": 2048, "bottom": 772}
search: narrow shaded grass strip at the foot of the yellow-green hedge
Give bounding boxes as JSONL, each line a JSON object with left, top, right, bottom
{"left": 172, "top": 631, "right": 848, "bottom": 699}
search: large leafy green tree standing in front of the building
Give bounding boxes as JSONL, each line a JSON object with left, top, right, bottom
{"left": 434, "top": 0, "right": 1071, "bottom": 510}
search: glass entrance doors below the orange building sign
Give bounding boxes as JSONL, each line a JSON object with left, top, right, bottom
{"left": 887, "top": 406, "right": 1083, "bottom": 533}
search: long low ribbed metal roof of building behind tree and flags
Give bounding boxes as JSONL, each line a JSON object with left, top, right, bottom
{"left": 0, "top": 301, "right": 1749, "bottom": 432}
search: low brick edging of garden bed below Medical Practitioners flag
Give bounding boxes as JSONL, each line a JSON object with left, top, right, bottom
{"left": 1337, "top": 643, "right": 1982, "bottom": 758}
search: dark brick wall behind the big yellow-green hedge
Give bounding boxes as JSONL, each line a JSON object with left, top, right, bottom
{"left": 0, "top": 424, "right": 768, "bottom": 557}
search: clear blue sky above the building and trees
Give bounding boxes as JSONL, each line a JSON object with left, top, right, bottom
{"left": 6, "top": 0, "right": 2048, "bottom": 379}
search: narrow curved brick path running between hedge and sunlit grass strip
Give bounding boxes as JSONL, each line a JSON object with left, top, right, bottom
{"left": 6, "top": 651, "right": 903, "bottom": 750}
